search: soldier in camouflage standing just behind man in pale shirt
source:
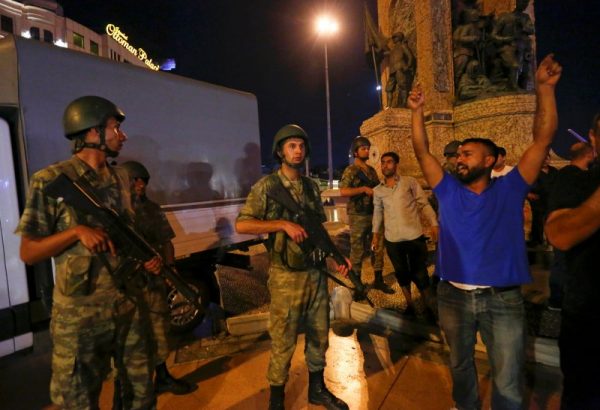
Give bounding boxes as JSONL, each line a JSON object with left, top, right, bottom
{"left": 340, "top": 137, "right": 394, "bottom": 294}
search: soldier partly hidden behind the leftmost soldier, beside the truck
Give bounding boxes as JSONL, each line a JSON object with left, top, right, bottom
{"left": 122, "top": 161, "right": 192, "bottom": 395}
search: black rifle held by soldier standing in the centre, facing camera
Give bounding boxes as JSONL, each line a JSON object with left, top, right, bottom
{"left": 267, "top": 182, "right": 372, "bottom": 304}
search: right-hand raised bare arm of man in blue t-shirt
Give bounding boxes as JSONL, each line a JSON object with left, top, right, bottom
{"left": 517, "top": 54, "right": 562, "bottom": 184}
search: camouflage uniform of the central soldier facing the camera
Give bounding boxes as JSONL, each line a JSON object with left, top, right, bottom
{"left": 238, "top": 169, "right": 329, "bottom": 386}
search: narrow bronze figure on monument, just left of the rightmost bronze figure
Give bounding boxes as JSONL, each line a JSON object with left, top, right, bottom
{"left": 452, "top": 8, "right": 482, "bottom": 88}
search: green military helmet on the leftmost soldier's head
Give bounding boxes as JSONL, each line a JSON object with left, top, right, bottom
{"left": 63, "top": 95, "right": 125, "bottom": 139}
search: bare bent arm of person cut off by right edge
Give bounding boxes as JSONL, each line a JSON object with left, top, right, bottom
{"left": 544, "top": 188, "right": 600, "bottom": 250}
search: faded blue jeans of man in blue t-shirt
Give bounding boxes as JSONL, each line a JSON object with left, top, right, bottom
{"left": 437, "top": 281, "right": 525, "bottom": 410}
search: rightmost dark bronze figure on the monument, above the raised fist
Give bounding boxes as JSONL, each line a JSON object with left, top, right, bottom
{"left": 492, "top": 0, "right": 535, "bottom": 90}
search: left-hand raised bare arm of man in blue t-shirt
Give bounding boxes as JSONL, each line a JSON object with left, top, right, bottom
{"left": 406, "top": 84, "right": 444, "bottom": 188}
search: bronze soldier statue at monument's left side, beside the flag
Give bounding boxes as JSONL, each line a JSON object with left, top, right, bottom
{"left": 385, "top": 32, "right": 416, "bottom": 108}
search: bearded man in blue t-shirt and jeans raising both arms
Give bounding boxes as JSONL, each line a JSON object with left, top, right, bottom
{"left": 407, "top": 55, "right": 561, "bottom": 409}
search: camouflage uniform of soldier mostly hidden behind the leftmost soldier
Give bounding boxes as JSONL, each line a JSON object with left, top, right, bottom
{"left": 133, "top": 196, "right": 175, "bottom": 365}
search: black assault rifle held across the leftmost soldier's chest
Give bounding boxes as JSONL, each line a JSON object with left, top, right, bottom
{"left": 44, "top": 174, "right": 204, "bottom": 313}
